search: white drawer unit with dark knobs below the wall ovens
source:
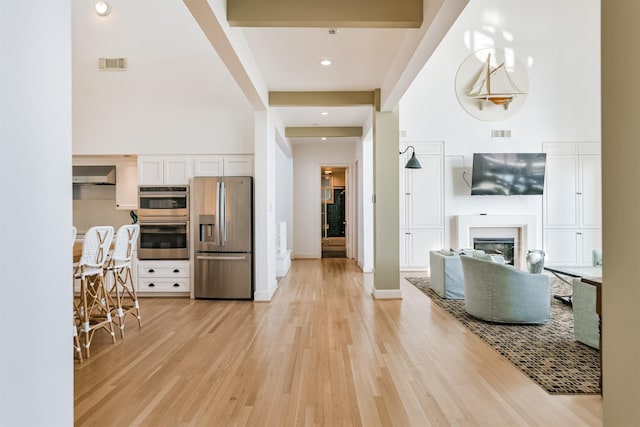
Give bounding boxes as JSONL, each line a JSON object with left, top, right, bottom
{"left": 138, "top": 260, "right": 189, "bottom": 293}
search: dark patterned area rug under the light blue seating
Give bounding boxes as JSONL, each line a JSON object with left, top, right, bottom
{"left": 406, "top": 277, "right": 600, "bottom": 394}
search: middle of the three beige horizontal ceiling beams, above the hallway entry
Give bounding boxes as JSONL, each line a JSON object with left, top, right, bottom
{"left": 269, "top": 90, "right": 380, "bottom": 107}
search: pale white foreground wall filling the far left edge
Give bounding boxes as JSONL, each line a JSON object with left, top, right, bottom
{"left": 0, "top": 0, "right": 74, "bottom": 426}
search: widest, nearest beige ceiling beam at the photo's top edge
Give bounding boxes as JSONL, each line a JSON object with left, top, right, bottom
{"left": 227, "top": 0, "right": 423, "bottom": 28}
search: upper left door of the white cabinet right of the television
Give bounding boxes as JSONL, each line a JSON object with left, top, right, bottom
{"left": 544, "top": 155, "right": 578, "bottom": 228}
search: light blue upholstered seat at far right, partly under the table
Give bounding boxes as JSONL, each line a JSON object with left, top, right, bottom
{"left": 571, "top": 279, "right": 600, "bottom": 348}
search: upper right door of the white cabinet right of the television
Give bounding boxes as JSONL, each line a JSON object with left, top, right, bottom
{"left": 578, "top": 156, "right": 602, "bottom": 227}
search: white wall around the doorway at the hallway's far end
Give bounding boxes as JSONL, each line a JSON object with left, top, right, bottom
{"left": 293, "top": 143, "right": 356, "bottom": 258}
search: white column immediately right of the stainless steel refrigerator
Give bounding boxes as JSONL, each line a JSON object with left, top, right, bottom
{"left": 253, "top": 111, "right": 278, "bottom": 301}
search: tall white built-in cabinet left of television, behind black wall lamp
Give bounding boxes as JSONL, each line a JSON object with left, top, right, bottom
{"left": 400, "top": 142, "right": 444, "bottom": 270}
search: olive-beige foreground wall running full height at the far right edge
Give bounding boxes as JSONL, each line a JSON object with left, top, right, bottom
{"left": 591, "top": 0, "right": 640, "bottom": 426}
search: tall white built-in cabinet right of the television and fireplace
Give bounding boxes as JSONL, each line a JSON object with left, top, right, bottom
{"left": 543, "top": 142, "right": 602, "bottom": 266}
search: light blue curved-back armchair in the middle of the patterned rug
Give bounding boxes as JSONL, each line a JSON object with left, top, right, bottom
{"left": 460, "top": 256, "right": 551, "bottom": 323}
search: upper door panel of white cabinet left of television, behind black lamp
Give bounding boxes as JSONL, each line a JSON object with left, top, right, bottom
{"left": 407, "top": 155, "right": 444, "bottom": 228}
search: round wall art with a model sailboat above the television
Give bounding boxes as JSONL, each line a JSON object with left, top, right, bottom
{"left": 456, "top": 48, "right": 529, "bottom": 122}
